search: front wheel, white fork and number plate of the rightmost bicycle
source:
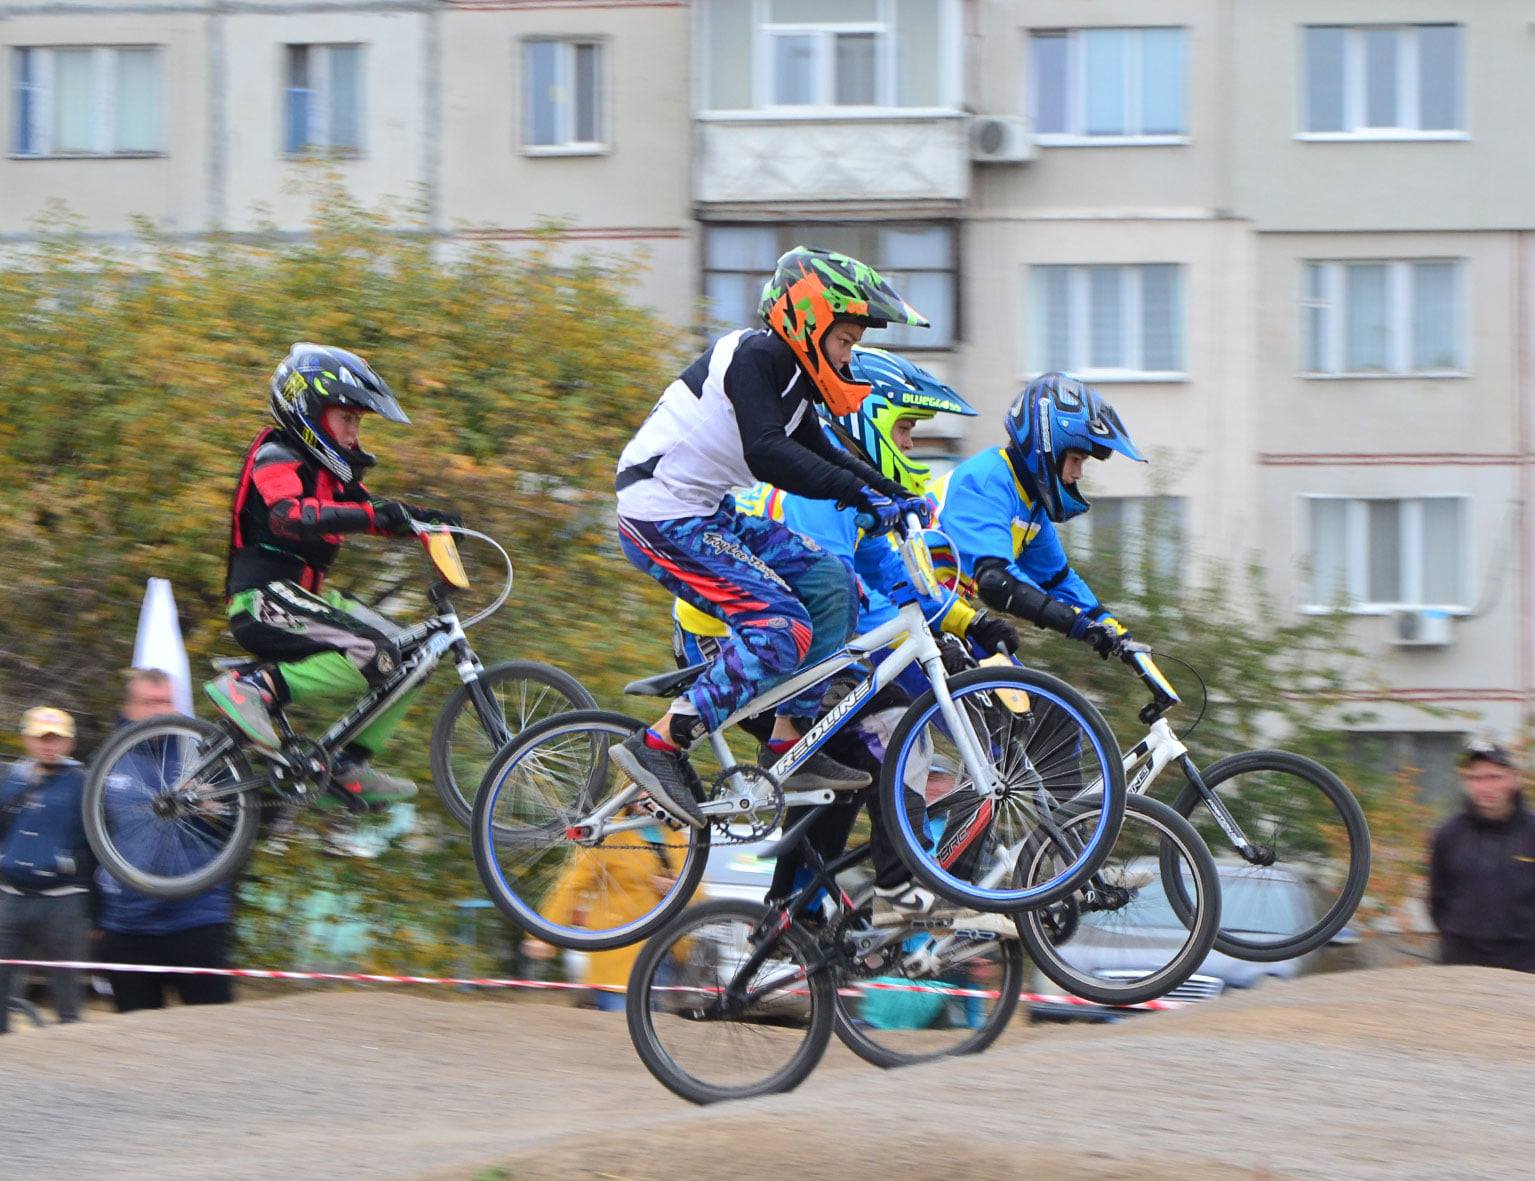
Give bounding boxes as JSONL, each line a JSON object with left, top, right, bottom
{"left": 1086, "top": 645, "right": 1371, "bottom": 964}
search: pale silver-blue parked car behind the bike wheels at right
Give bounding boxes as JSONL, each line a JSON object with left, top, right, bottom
{"left": 1028, "top": 863, "right": 1357, "bottom": 1021}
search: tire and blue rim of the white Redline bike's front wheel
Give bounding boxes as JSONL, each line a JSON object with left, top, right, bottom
{"left": 878, "top": 668, "right": 1127, "bottom": 914}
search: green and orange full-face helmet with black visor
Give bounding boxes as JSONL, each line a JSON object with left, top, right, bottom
{"left": 757, "top": 246, "right": 930, "bottom": 415}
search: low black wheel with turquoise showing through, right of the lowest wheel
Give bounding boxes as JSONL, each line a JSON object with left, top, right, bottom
{"left": 834, "top": 931, "right": 1024, "bottom": 1069}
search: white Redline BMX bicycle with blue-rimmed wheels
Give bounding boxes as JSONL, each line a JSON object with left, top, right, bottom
{"left": 470, "top": 516, "right": 1125, "bottom": 951}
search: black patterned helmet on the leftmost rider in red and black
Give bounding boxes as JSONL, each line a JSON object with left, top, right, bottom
{"left": 272, "top": 341, "right": 410, "bottom": 484}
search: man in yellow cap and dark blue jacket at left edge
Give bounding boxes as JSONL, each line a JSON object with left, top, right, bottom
{"left": 0, "top": 706, "right": 94, "bottom": 1034}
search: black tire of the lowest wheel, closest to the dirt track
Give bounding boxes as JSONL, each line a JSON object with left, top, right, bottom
{"left": 625, "top": 898, "right": 835, "bottom": 1104}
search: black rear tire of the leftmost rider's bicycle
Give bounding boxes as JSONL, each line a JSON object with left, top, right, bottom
{"left": 81, "top": 716, "right": 261, "bottom": 900}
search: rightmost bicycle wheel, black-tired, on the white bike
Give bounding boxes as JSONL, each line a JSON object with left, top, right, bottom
{"left": 1170, "top": 751, "right": 1369, "bottom": 963}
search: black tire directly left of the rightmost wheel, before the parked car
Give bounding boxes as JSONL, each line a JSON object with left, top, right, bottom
{"left": 1016, "top": 796, "right": 1220, "bottom": 1004}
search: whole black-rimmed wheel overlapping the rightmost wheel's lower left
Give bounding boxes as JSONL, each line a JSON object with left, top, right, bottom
{"left": 1018, "top": 796, "right": 1220, "bottom": 1004}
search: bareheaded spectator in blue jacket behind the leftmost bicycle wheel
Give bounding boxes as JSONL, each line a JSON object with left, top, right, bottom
{"left": 97, "top": 668, "right": 235, "bottom": 1014}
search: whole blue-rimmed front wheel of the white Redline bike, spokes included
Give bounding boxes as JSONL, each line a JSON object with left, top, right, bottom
{"left": 880, "top": 668, "right": 1125, "bottom": 912}
